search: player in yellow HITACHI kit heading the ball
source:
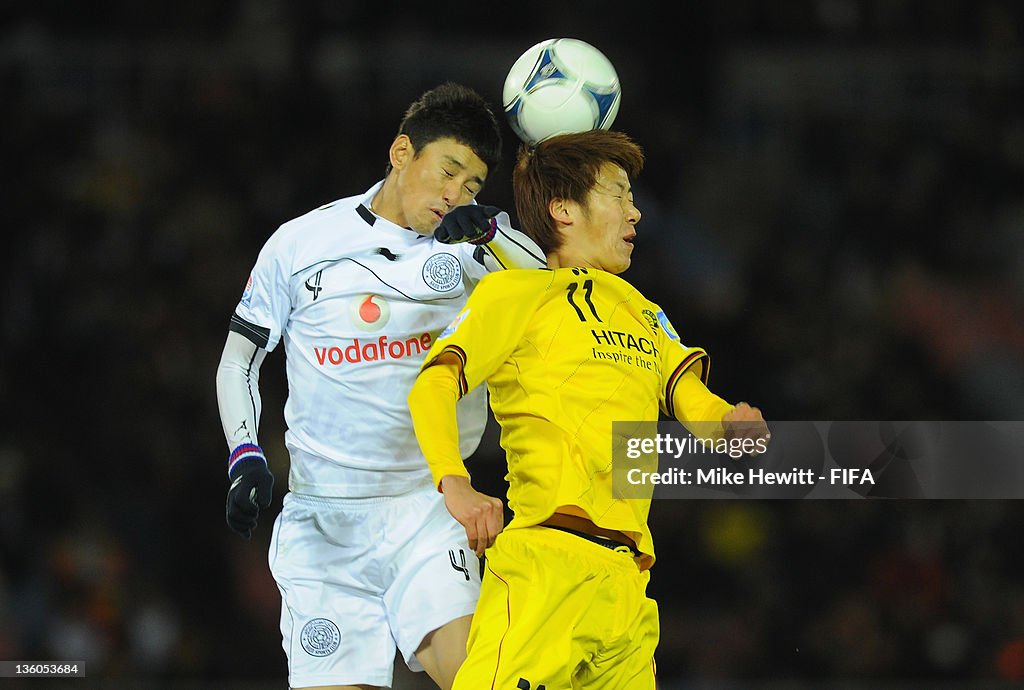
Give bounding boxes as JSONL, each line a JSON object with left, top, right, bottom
{"left": 409, "top": 130, "right": 768, "bottom": 690}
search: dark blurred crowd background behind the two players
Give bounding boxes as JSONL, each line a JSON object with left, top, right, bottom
{"left": 0, "top": 0, "right": 1024, "bottom": 689}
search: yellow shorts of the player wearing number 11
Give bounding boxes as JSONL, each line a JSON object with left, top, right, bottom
{"left": 453, "top": 527, "right": 658, "bottom": 690}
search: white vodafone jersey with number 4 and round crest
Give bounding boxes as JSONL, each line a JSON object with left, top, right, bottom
{"left": 230, "top": 183, "right": 520, "bottom": 497}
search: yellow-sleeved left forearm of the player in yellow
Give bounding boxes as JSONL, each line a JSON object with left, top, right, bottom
{"left": 409, "top": 363, "right": 469, "bottom": 486}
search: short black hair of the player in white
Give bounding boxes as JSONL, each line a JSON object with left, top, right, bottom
{"left": 384, "top": 82, "right": 502, "bottom": 175}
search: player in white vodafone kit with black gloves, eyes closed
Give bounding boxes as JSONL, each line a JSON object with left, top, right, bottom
{"left": 217, "top": 84, "right": 544, "bottom": 689}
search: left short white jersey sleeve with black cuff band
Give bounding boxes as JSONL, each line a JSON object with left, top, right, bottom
{"left": 228, "top": 230, "right": 293, "bottom": 351}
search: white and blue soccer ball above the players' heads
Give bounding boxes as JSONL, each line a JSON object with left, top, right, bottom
{"left": 502, "top": 38, "right": 622, "bottom": 146}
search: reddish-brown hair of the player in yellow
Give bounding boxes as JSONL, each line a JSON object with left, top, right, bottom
{"left": 512, "top": 129, "right": 644, "bottom": 254}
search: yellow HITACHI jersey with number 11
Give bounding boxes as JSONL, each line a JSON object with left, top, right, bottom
{"left": 421, "top": 268, "right": 727, "bottom": 567}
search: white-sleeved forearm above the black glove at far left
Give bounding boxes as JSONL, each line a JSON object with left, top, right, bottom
{"left": 217, "top": 332, "right": 266, "bottom": 449}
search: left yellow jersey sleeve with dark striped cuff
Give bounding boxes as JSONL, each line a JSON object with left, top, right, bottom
{"left": 423, "top": 270, "right": 553, "bottom": 396}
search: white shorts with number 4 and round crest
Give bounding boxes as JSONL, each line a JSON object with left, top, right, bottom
{"left": 269, "top": 484, "right": 480, "bottom": 688}
